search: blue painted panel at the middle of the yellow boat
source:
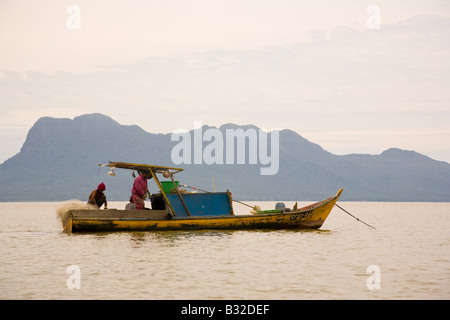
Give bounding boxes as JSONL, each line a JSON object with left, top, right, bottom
{"left": 166, "top": 192, "right": 231, "bottom": 217}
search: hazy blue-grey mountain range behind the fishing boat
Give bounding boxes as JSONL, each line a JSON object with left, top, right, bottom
{"left": 0, "top": 113, "right": 450, "bottom": 202}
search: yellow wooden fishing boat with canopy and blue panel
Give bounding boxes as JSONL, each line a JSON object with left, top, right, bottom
{"left": 61, "top": 162, "right": 342, "bottom": 232}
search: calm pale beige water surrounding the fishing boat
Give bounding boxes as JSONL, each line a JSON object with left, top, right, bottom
{"left": 0, "top": 202, "right": 450, "bottom": 300}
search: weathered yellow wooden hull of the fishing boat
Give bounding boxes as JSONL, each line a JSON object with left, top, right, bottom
{"left": 62, "top": 189, "right": 342, "bottom": 232}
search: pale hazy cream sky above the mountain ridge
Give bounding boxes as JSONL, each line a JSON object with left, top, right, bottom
{"left": 0, "top": 0, "right": 450, "bottom": 163}
